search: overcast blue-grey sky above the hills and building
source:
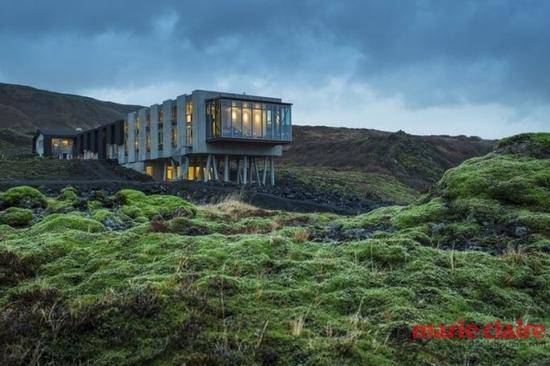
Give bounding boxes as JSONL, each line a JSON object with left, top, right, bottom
{"left": 0, "top": 0, "right": 550, "bottom": 138}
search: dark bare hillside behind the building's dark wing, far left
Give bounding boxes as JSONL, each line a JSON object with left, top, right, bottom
{"left": 0, "top": 83, "right": 140, "bottom": 134}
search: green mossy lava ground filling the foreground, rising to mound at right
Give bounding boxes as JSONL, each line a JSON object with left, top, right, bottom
{"left": 0, "top": 134, "right": 550, "bottom": 365}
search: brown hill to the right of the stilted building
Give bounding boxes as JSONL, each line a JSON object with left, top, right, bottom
{"left": 281, "top": 126, "right": 496, "bottom": 190}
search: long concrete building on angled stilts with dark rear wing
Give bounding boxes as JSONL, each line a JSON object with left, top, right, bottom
{"left": 34, "top": 90, "right": 292, "bottom": 185}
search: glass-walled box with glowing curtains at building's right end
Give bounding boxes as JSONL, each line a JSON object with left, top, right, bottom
{"left": 206, "top": 98, "right": 292, "bottom": 142}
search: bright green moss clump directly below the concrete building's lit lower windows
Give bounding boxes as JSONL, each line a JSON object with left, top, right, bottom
{"left": 116, "top": 189, "right": 197, "bottom": 219}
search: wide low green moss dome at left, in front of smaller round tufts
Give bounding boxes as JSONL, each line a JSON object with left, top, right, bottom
{"left": 31, "top": 213, "right": 105, "bottom": 234}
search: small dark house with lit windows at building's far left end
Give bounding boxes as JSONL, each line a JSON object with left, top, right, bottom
{"left": 32, "top": 128, "right": 79, "bottom": 159}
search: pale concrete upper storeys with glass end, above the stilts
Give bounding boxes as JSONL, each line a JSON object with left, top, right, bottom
{"left": 119, "top": 90, "right": 292, "bottom": 163}
